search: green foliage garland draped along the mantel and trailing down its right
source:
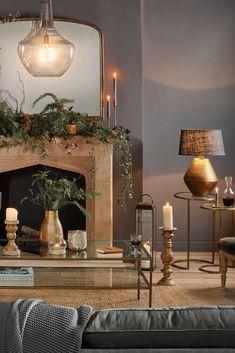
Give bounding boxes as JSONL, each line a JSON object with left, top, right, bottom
{"left": 0, "top": 91, "right": 133, "bottom": 210}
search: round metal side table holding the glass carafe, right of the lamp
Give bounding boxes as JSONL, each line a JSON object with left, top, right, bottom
{"left": 199, "top": 203, "right": 235, "bottom": 273}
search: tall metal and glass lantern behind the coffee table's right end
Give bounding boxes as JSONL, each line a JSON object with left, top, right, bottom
{"left": 135, "top": 194, "right": 156, "bottom": 270}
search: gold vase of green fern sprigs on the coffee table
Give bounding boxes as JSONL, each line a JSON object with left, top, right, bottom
{"left": 21, "top": 170, "right": 100, "bottom": 247}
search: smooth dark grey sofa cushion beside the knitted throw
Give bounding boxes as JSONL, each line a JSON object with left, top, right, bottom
{"left": 83, "top": 306, "right": 235, "bottom": 349}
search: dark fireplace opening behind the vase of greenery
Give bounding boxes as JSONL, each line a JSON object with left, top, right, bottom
{"left": 0, "top": 164, "right": 86, "bottom": 239}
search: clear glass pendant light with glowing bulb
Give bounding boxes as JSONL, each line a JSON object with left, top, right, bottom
{"left": 18, "top": 0, "right": 74, "bottom": 77}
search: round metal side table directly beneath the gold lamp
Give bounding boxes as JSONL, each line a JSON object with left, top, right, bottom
{"left": 172, "top": 192, "right": 215, "bottom": 270}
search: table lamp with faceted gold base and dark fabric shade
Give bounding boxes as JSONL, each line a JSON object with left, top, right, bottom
{"left": 179, "top": 130, "right": 225, "bottom": 197}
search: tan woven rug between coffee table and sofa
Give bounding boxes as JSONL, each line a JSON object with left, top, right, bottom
{"left": 0, "top": 286, "right": 193, "bottom": 309}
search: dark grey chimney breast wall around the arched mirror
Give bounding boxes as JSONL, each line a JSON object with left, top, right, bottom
{"left": 0, "top": 0, "right": 142, "bottom": 238}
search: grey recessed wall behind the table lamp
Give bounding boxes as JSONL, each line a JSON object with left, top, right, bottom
{"left": 142, "top": 0, "right": 235, "bottom": 250}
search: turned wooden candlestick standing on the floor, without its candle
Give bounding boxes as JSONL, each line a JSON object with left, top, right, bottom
{"left": 157, "top": 227, "right": 177, "bottom": 286}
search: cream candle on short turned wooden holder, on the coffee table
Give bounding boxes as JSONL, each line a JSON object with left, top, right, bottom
{"left": 2, "top": 208, "right": 20, "bottom": 256}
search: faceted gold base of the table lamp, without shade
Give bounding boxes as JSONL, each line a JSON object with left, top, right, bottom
{"left": 184, "top": 157, "right": 218, "bottom": 197}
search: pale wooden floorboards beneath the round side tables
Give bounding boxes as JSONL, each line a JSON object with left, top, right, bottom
{"left": 154, "top": 252, "right": 235, "bottom": 305}
